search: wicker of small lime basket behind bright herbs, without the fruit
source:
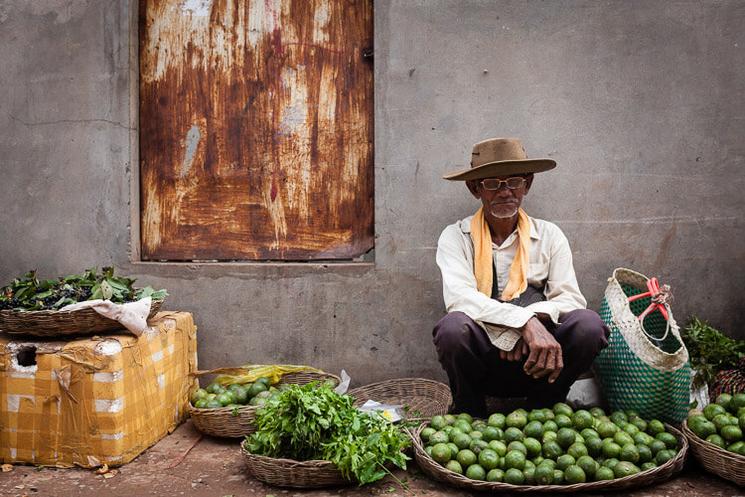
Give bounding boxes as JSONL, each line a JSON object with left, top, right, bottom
{"left": 189, "top": 370, "right": 340, "bottom": 438}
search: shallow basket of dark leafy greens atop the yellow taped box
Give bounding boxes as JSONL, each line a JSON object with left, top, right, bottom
{"left": 0, "top": 267, "right": 168, "bottom": 337}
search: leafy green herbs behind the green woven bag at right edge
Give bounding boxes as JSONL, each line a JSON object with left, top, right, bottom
{"left": 682, "top": 316, "right": 745, "bottom": 384}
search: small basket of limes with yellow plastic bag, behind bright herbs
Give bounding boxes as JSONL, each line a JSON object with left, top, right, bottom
{"left": 189, "top": 366, "right": 340, "bottom": 438}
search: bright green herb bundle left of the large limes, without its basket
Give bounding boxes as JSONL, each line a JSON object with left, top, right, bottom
{"left": 246, "top": 383, "right": 410, "bottom": 485}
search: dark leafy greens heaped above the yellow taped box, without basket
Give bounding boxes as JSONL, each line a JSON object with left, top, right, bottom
{"left": 0, "top": 267, "right": 168, "bottom": 311}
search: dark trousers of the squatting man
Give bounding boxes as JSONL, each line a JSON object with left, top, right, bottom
{"left": 433, "top": 309, "right": 610, "bottom": 417}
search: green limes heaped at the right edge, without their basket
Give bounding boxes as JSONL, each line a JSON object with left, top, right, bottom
{"left": 687, "top": 392, "right": 745, "bottom": 456}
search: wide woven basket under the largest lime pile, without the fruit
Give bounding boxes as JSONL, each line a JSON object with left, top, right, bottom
{"left": 411, "top": 423, "right": 688, "bottom": 493}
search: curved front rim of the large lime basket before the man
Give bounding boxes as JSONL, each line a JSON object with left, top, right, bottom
{"left": 409, "top": 423, "right": 689, "bottom": 493}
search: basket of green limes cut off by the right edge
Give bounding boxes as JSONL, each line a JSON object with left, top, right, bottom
{"left": 683, "top": 392, "right": 745, "bottom": 486}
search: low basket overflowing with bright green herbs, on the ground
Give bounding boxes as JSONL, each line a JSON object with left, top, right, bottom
{"left": 241, "top": 382, "right": 410, "bottom": 488}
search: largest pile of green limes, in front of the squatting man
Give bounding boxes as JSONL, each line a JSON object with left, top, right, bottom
{"left": 421, "top": 402, "right": 678, "bottom": 485}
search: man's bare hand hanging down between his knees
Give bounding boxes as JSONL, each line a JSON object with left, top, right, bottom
{"left": 510, "top": 317, "right": 564, "bottom": 383}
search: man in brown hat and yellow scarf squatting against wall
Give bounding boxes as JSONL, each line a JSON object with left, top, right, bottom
{"left": 433, "top": 138, "right": 610, "bottom": 417}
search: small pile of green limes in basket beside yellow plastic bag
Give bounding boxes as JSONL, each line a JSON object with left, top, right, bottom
{"left": 191, "top": 378, "right": 279, "bottom": 409}
